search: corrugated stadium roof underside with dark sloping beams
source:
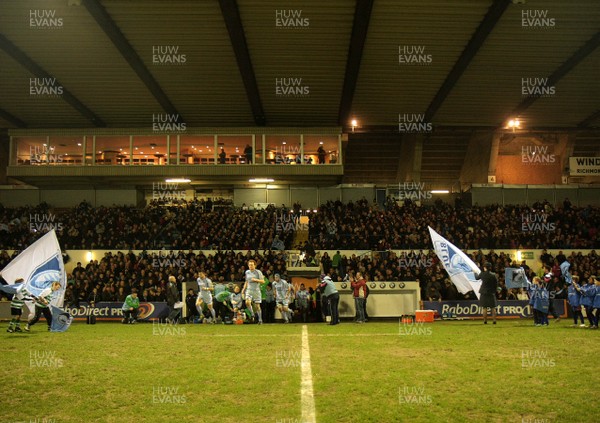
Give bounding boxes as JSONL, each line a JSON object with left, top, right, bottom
{"left": 0, "top": 0, "right": 600, "bottom": 129}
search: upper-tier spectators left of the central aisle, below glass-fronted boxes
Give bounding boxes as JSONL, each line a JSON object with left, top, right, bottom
{"left": 0, "top": 200, "right": 294, "bottom": 250}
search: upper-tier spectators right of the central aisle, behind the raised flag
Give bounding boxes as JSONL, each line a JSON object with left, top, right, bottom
{"left": 309, "top": 199, "right": 600, "bottom": 251}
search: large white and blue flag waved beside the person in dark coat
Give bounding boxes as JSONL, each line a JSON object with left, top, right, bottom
{"left": 428, "top": 226, "right": 481, "bottom": 298}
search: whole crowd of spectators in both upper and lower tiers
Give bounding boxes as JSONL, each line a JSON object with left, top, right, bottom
{"left": 0, "top": 198, "right": 600, "bottom": 301}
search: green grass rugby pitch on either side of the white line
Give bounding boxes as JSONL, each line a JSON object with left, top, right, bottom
{"left": 0, "top": 319, "right": 600, "bottom": 423}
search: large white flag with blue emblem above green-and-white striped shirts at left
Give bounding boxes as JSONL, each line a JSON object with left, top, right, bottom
{"left": 0, "top": 229, "right": 67, "bottom": 307}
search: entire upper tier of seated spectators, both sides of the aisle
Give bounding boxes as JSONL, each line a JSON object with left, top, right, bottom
{"left": 0, "top": 199, "right": 600, "bottom": 251}
